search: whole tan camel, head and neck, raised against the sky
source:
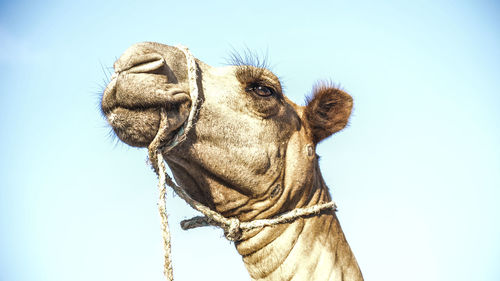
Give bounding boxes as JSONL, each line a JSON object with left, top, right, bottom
{"left": 101, "top": 42, "right": 363, "bottom": 281}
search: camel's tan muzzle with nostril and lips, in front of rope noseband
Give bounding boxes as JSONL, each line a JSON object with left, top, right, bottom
{"left": 101, "top": 43, "right": 191, "bottom": 147}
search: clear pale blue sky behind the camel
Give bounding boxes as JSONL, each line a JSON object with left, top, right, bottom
{"left": 0, "top": 0, "right": 500, "bottom": 281}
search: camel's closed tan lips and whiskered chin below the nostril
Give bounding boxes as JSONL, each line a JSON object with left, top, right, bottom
{"left": 101, "top": 69, "right": 191, "bottom": 147}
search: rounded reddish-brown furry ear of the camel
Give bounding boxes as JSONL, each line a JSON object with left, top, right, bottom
{"left": 305, "top": 84, "right": 352, "bottom": 144}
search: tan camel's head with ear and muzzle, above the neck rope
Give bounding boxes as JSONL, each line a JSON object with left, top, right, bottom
{"left": 102, "top": 40, "right": 352, "bottom": 233}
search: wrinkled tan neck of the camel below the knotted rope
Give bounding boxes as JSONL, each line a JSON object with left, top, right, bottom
{"left": 236, "top": 177, "right": 363, "bottom": 281}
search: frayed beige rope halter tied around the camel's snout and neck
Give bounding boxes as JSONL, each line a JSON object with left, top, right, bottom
{"left": 148, "top": 46, "right": 337, "bottom": 281}
